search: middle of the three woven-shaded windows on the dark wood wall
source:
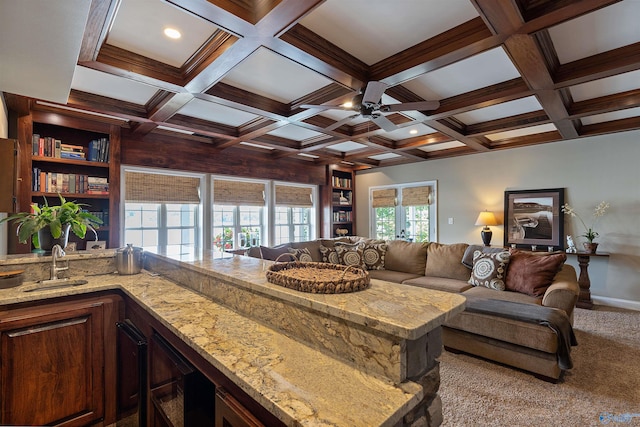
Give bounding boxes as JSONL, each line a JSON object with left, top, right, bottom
{"left": 212, "top": 179, "right": 266, "bottom": 251}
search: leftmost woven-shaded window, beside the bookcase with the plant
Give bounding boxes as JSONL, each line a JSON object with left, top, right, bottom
{"left": 124, "top": 170, "right": 202, "bottom": 255}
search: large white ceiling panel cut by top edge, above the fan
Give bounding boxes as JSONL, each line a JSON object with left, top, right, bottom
{"left": 301, "top": 0, "right": 478, "bottom": 65}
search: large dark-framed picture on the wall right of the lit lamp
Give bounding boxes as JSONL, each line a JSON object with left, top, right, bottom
{"left": 504, "top": 188, "right": 564, "bottom": 251}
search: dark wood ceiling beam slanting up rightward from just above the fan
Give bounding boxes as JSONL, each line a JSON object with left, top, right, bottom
{"left": 370, "top": 18, "right": 501, "bottom": 86}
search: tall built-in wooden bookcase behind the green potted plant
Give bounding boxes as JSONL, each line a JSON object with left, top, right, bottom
{"left": 11, "top": 110, "right": 120, "bottom": 253}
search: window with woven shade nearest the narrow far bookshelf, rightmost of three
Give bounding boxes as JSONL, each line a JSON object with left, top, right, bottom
{"left": 274, "top": 184, "right": 315, "bottom": 245}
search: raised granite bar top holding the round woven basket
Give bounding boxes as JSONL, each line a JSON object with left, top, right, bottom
{"left": 147, "top": 252, "right": 465, "bottom": 340}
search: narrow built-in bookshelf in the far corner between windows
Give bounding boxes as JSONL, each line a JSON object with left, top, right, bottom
{"left": 323, "top": 166, "right": 356, "bottom": 237}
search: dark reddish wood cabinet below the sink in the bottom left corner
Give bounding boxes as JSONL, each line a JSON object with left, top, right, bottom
{"left": 0, "top": 296, "right": 121, "bottom": 427}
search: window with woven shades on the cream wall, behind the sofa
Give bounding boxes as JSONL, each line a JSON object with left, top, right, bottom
{"left": 371, "top": 182, "right": 437, "bottom": 242}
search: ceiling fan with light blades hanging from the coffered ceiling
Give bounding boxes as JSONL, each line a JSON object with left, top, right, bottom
{"left": 300, "top": 81, "right": 440, "bottom": 132}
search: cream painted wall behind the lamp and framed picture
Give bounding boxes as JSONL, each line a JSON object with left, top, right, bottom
{"left": 356, "top": 131, "right": 640, "bottom": 308}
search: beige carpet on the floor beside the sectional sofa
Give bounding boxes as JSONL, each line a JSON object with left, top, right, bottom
{"left": 439, "top": 306, "right": 640, "bottom": 427}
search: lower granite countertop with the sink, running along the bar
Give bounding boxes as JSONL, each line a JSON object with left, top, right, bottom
{"left": 0, "top": 271, "right": 423, "bottom": 427}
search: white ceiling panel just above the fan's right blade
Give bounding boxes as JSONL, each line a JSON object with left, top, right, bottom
{"left": 403, "top": 47, "right": 520, "bottom": 100}
